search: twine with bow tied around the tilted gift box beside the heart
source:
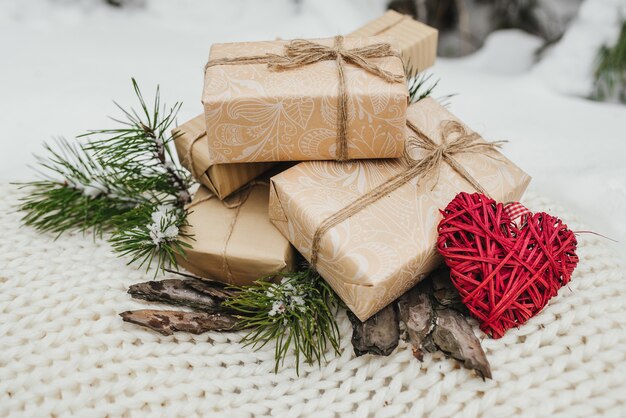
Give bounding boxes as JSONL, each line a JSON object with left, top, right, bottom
{"left": 311, "top": 120, "right": 504, "bottom": 267}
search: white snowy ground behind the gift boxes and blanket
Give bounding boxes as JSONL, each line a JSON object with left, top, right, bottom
{"left": 0, "top": 0, "right": 626, "bottom": 257}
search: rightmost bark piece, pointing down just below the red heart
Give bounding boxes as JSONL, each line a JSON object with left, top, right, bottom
{"left": 432, "top": 308, "right": 491, "bottom": 379}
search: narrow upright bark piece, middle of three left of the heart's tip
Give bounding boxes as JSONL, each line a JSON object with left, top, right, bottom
{"left": 398, "top": 280, "right": 435, "bottom": 361}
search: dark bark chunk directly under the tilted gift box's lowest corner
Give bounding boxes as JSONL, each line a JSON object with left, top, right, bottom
{"left": 348, "top": 303, "right": 400, "bottom": 356}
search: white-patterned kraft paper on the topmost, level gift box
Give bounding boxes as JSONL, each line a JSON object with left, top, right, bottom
{"left": 202, "top": 37, "right": 408, "bottom": 163}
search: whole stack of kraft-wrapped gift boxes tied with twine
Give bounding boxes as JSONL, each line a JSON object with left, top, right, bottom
{"left": 169, "top": 12, "right": 530, "bottom": 321}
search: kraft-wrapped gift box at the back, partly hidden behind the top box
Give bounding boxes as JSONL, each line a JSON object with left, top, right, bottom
{"left": 348, "top": 10, "right": 438, "bottom": 71}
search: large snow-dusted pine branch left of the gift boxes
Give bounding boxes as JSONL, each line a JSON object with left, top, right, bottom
{"left": 19, "top": 79, "right": 192, "bottom": 274}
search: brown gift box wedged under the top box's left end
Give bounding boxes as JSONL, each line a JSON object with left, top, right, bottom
{"left": 172, "top": 115, "right": 274, "bottom": 200}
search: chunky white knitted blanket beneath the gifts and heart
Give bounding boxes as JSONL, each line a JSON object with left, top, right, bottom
{"left": 0, "top": 185, "right": 626, "bottom": 417}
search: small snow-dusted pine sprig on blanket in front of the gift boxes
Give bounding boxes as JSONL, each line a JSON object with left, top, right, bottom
{"left": 225, "top": 268, "right": 340, "bottom": 374}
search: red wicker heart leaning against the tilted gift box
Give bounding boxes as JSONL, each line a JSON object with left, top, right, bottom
{"left": 437, "top": 193, "right": 578, "bottom": 338}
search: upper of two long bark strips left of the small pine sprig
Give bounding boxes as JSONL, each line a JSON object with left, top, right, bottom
{"left": 128, "top": 279, "right": 232, "bottom": 312}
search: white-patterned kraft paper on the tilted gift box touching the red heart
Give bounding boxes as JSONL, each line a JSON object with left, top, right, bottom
{"left": 270, "top": 99, "right": 530, "bottom": 321}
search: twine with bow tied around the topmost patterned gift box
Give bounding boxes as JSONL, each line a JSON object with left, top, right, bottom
{"left": 204, "top": 36, "right": 404, "bottom": 161}
